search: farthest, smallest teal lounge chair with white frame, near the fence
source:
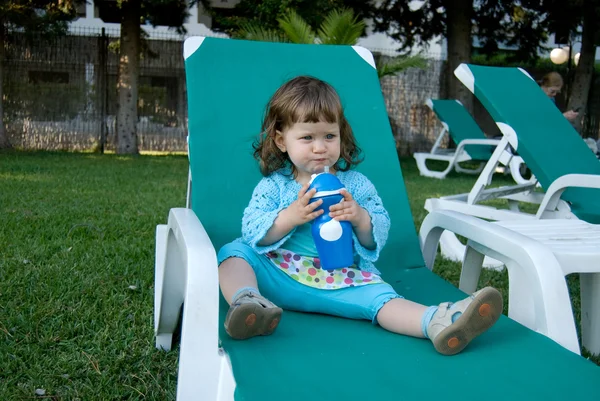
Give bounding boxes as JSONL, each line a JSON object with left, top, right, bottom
{"left": 413, "top": 99, "right": 534, "bottom": 184}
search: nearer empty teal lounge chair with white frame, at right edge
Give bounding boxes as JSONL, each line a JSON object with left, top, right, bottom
{"left": 425, "top": 64, "right": 600, "bottom": 354}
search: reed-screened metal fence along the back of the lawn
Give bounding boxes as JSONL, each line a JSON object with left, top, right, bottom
{"left": 4, "top": 29, "right": 600, "bottom": 155}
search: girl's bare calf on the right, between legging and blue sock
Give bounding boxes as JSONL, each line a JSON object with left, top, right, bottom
{"left": 377, "top": 298, "right": 429, "bottom": 338}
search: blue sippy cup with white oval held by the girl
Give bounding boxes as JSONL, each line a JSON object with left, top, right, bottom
{"left": 308, "top": 167, "right": 354, "bottom": 270}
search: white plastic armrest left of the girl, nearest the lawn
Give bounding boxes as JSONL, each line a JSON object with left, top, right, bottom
{"left": 157, "top": 208, "right": 224, "bottom": 399}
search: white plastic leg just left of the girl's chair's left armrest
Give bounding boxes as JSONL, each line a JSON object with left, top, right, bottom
{"left": 154, "top": 225, "right": 185, "bottom": 351}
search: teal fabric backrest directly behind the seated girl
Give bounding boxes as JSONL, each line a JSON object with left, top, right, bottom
{"left": 184, "top": 37, "right": 424, "bottom": 272}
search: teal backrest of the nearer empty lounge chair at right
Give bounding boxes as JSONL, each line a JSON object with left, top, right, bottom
{"left": 454, "top": 64, "right": 600, "bottom": 223}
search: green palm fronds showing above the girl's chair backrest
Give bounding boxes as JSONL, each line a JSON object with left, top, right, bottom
{"left": 236, "top": 9, "right": 427, "bottom": 78}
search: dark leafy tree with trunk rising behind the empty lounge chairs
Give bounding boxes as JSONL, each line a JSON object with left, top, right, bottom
{"left": 374, "top": 0, "right": 547, "bottom": 109}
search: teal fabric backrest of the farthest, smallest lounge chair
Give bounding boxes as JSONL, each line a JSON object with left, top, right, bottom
{"left": 430, "top": 99, "right": 495, "bottom": 160}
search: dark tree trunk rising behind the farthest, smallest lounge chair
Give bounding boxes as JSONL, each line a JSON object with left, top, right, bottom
{"left": 445, "top": 0, "right": 473, "bottom": 113}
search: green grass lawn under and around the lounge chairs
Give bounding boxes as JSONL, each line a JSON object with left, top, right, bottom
{"left": 0, "top": 152, "right": 598, "bottom": 401}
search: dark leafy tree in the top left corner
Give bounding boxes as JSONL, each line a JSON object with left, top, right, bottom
{"left": 0, "top": 0, "right": 76, "bottom": 149}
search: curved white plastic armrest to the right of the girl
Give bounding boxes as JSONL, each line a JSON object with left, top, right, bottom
{"left": 419, "top": 210, "right": 579, "bottom": 353}
